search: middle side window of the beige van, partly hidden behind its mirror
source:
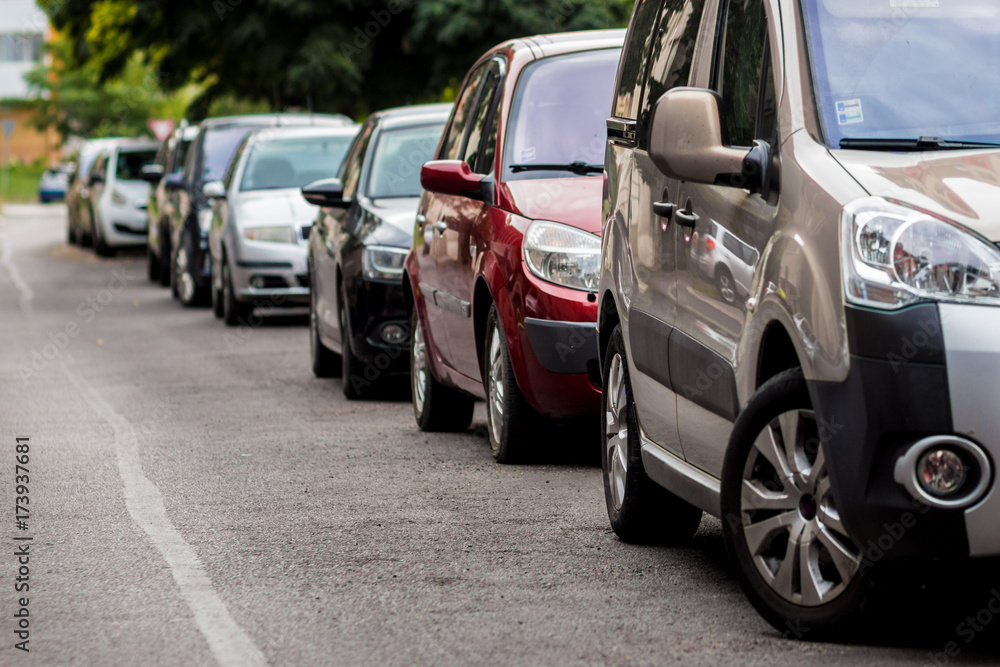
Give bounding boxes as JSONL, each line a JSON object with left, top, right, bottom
{"left": 636, "top": 0, "right": 705, "bottom": 148}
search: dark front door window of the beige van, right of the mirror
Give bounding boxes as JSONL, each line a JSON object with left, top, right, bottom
{"left": 715, "top": 0, "right": 767, "bottom": 146}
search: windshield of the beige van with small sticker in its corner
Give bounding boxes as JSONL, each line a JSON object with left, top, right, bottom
{"left": 802, "top": 0, "right": 1000, "bottom": 147}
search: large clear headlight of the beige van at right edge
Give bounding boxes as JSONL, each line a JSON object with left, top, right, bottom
{"left": 842, "top": 197, "right": 1000, "bottom": 310}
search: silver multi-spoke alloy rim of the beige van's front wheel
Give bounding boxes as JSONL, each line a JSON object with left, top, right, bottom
{"left": 740, "top": 410, "right": 862, "bottom": 607}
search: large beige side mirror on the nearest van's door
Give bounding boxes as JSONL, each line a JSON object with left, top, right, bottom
{"left": 649, "top": 88, "right": 771, "bottom": 198}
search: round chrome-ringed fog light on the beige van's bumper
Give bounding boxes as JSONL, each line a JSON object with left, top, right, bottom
{"left": 893, "top": 436, "right": 993, "bottom": 509}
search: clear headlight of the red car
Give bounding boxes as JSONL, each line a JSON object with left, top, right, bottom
{"left": 523, "top": 221, "right": 601, "bottom": 292}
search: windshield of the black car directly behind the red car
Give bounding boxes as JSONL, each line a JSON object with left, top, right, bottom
{"left": 366, "top": 123, "right": 444, "bottom": 199}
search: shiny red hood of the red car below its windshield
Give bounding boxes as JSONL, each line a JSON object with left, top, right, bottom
{"left": 500, "top": 176, "right": 604, "bottom": 234}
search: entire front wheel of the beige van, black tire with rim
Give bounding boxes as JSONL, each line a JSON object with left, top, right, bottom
{"left": 722, "top": 369, "right": 874, "bottom": 640}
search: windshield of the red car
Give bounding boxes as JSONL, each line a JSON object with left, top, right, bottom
{"left": 504, "top": 49, "right": 621, "bottom": 181}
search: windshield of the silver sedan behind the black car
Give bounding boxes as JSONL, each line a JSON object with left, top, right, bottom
{"left": 240, "top": 135, "right": 354, "bottom": 192}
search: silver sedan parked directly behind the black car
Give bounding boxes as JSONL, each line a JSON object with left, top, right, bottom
{"left": 204, "top": 125, "right": 358, "bottom": 326}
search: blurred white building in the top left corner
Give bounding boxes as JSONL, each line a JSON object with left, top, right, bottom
{"left": 0, "top": 0, "right": 49, "bottom": 100}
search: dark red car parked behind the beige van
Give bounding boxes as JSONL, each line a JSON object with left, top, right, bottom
{"left": 404, "top": 31, "right": 625, "bottom": 462}
